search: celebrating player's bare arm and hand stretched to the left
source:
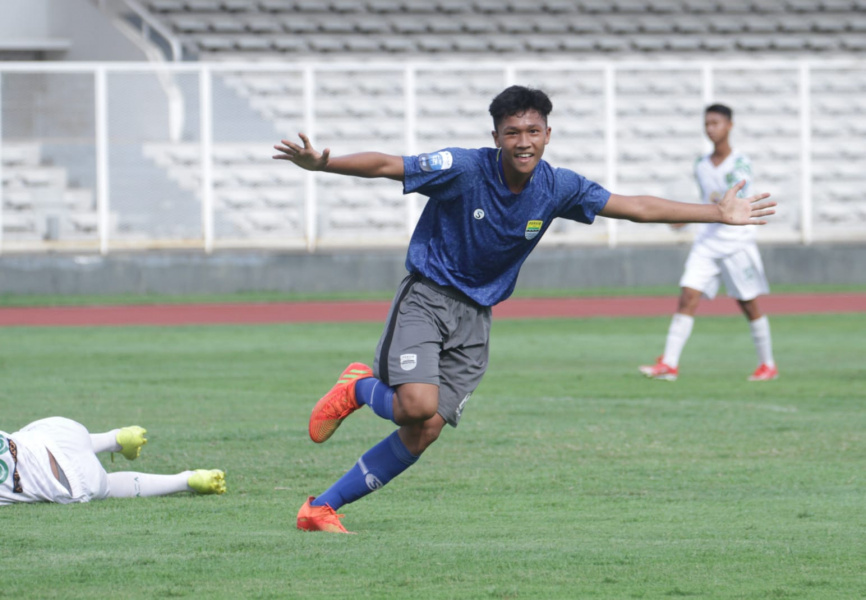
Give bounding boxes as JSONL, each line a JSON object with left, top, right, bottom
{"left": 273, "top": 133, "right": 403, "bottom": 181}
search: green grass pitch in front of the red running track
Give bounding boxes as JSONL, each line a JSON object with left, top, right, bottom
{"left": 0, "top": 314, "right": 866, "bottom": 599}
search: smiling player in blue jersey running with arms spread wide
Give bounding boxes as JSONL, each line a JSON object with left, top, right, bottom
{"left": 274, "top": 86, "right": 775, "bottom": 533}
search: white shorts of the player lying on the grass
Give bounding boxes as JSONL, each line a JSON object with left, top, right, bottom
{"left": 21, "top": 417, "right": 108, "bottom": 504}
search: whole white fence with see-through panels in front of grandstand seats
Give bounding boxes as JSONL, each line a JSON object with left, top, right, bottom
{"left": 0, "top": 60, "right": 866, "bottom": 254}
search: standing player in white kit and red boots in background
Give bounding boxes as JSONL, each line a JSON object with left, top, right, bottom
{"left": 640, "top": 104, "right": 779, "bottom": 381}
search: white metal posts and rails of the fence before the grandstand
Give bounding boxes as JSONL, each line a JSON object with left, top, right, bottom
{"left": 0, "top": 59, "right": 866, "bottom": 254}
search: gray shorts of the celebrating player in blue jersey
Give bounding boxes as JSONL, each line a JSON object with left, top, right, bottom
{"left": 373, "top": 275, "right": 491, "bottom": 427}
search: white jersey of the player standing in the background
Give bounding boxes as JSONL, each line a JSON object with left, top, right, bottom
{"left": 695, "top": 150, "right": 755, "bottom": 244}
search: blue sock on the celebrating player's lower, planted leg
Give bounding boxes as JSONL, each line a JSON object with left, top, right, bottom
{"left": 310, "top": 431, "right": 418, "bottom": 510}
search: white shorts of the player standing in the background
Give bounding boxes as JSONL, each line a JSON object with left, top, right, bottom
{"left": 680, "top": 242, "right": 770, "bottom": 300}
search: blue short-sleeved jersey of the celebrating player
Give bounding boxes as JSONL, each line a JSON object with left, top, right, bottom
{"left": 403, "top": 148, "right": 610, "bottom": 306}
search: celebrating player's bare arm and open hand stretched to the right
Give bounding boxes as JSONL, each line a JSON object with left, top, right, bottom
{"left": 599, "top": 181, "right": 776, "bottom": 225}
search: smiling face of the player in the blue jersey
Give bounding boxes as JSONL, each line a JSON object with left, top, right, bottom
{"left": 493, "top": 110, "right": 550, "bottom": 191}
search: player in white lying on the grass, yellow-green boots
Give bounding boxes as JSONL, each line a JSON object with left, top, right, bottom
{"left": 0, "top": 417, "right": 226, "bottom": 505}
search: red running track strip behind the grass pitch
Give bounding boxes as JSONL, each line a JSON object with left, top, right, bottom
{"left": 0, "top": 294, "right": 866, "bottom": 327}
